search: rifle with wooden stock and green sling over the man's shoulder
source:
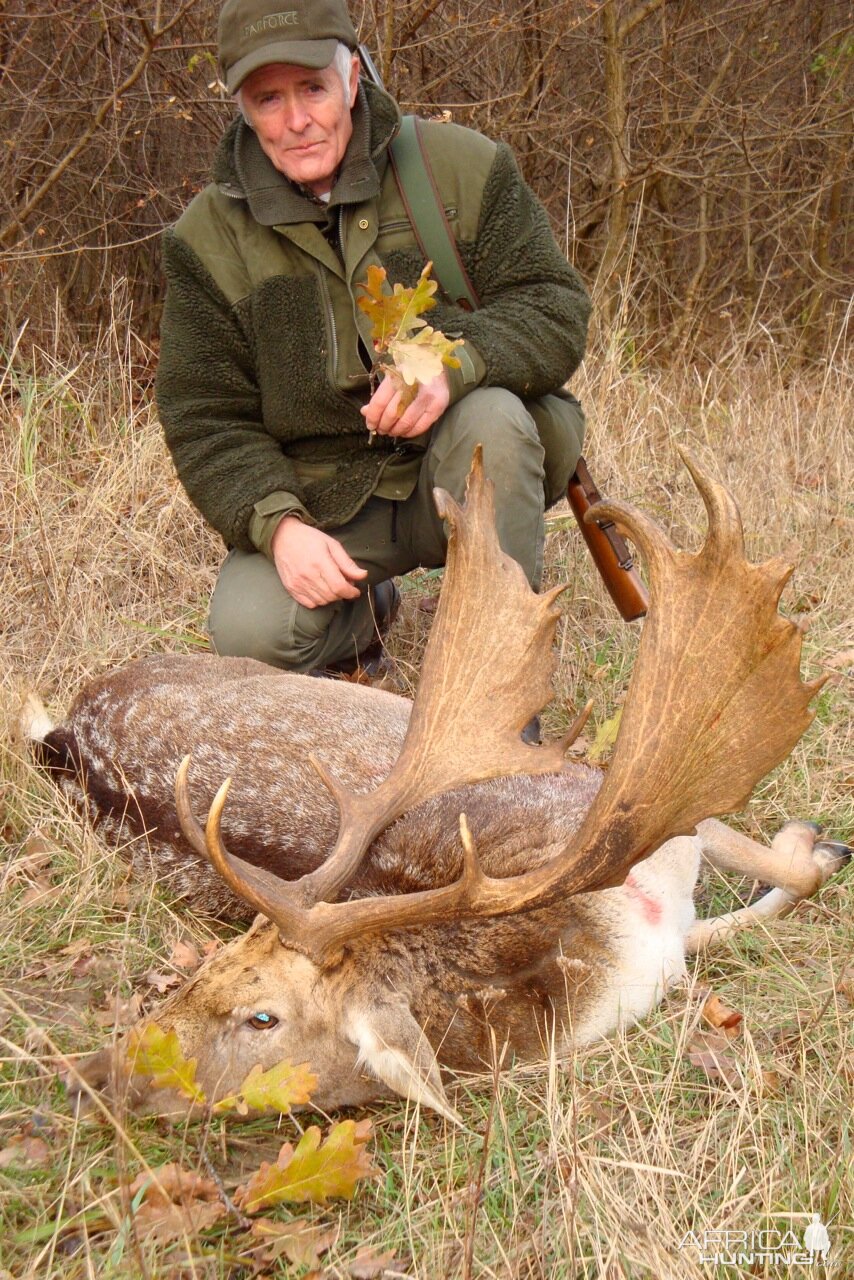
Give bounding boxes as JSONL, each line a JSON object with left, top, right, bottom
{"left": 359, "top": 45, "right": 649, "bottom": 622}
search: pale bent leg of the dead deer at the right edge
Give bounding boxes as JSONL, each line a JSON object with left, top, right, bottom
{"left": 685, "top": 819, "right": 851, "bottom": 955}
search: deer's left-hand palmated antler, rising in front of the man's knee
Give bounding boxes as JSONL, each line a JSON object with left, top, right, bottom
{"left": 272, "top": 447, "right": 565, "bottom": 906}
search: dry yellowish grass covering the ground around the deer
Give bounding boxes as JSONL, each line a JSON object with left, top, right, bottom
{"left": 0, "top": 322, "right": 854, "bottom": 1280}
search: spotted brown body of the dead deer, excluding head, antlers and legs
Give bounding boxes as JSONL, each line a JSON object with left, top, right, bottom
{"left": 41, "top": 655, "right": 700, "bottom": 1070}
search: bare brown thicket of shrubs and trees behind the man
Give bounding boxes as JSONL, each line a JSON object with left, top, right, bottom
{"left": 0, "top": 0, "right": 854, "bottom": 365}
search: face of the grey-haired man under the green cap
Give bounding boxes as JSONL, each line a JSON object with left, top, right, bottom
{"left": 242, "top": 61, "right": 359, "bottom": 196}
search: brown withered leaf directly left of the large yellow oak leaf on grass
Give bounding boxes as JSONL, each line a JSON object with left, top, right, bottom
{"left": 128, "top": 1162, "right": 228, "bottom": 1244}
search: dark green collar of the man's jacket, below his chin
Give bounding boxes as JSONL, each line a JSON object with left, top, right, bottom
{"left": 214, "top": 82, "right": 401, "bottom": 227}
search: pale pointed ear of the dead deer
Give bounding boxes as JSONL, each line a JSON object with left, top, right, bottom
{"left": 348, "top": 1000, "right": 462, "bottom": 1125}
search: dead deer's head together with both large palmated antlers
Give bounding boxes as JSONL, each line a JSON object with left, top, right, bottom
{"left": 71, "top": 454, "right": 821, "bottom": 1115}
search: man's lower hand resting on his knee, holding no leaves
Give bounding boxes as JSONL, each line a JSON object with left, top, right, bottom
{"left": 270, "top": 516, "right": 367, "bottom": 609}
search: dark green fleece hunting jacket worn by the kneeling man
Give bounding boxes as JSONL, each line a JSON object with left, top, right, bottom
{"left": 157, "top": 84, "right": 589, "bottom": 550}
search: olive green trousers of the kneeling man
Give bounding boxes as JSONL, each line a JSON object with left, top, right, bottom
{"left": 209, "top": 388, "right": 584, "bottom": 671}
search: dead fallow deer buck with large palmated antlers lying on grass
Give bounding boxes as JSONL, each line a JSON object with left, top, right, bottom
{"left": 29, "top": 458, "right": 850, "bottom": 1117}
